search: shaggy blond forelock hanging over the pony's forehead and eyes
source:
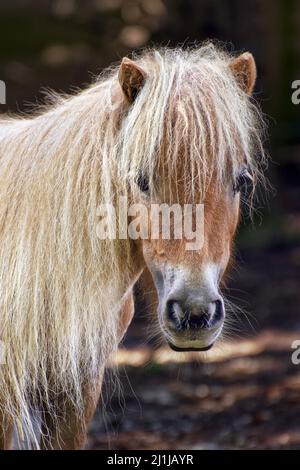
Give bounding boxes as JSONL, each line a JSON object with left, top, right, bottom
{"left": 119, "top": 43, "right": 266, "bottom": 203}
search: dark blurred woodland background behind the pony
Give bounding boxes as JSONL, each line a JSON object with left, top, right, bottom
{"left": 0, "top": 0, "right": 300, "bottom": 449}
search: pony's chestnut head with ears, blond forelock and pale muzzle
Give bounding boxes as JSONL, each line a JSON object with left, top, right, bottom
{"left": 119, "top": 44, "right": 263, "bottom": 351}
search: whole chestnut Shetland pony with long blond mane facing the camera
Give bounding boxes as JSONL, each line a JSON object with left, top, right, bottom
{"left": 0, "top": 44, "right": 263, "bottom": 449}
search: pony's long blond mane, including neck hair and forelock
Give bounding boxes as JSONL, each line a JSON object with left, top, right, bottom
{"left": 0, "top": 44, "right": 263, "bottom": 448}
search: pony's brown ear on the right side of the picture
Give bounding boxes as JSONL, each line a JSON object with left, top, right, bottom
{"left": 229, "top": 52, "right": 256, "bottom": 95}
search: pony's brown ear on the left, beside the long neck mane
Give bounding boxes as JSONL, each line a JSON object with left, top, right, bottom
{"left": 119, "top": 57, "right": 146, "bottom": 103}
